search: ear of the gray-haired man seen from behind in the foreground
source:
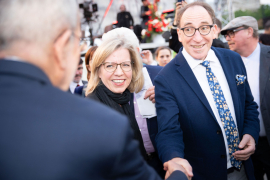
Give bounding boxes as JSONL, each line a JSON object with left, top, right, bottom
{"left": 53, "top": 30, "right": 72, "bottom": 69}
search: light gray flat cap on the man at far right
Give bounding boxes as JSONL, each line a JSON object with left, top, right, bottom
{"left": 220, "top": 16, "right": 259, "bottom": 35}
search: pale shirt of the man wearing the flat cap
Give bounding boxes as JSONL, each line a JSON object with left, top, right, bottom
{"left": 242, "top": 43, "right": 266, "bottom": 136}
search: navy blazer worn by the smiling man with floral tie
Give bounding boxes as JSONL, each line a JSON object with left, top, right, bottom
{"left": 155, "top": 47, "right": 260, "bottom": 180}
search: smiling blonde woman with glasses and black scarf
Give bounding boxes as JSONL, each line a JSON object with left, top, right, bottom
{"left": 86, "top": 37, "right": 147, "bottom": 159}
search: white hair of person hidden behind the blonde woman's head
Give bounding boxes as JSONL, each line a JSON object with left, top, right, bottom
{"left": 102, "top": 27, "right": 140, "bottom": 48}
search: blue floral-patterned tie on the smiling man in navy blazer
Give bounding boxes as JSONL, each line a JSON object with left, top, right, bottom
{"left": 201, "top": 61, "right": 242, "bottom": 169}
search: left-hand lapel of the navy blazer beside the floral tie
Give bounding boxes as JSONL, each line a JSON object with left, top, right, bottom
{"left": 175, "top": 51, "right": 217, "bottom": 121}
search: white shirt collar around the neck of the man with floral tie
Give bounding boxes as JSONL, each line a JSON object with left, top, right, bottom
{"left": 182, "top": 48, "right": 218, "bottom": 69}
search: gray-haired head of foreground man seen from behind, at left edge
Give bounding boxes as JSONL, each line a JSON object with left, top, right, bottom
{"left": 0, "top": 0, "right": 80, "bottom": 90}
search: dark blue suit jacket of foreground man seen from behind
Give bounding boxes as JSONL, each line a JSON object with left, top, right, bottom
{"left": 0, "top": 59, "right": 187, "bottom": 180}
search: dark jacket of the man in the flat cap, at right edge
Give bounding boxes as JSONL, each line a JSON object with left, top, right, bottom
{"left": 259, "top": 44, "right": 270, "bottom": 144}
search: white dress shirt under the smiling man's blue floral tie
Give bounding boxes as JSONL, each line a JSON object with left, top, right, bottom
{"left": 182, "top": 48, "right": 238, "bottom": 168}
